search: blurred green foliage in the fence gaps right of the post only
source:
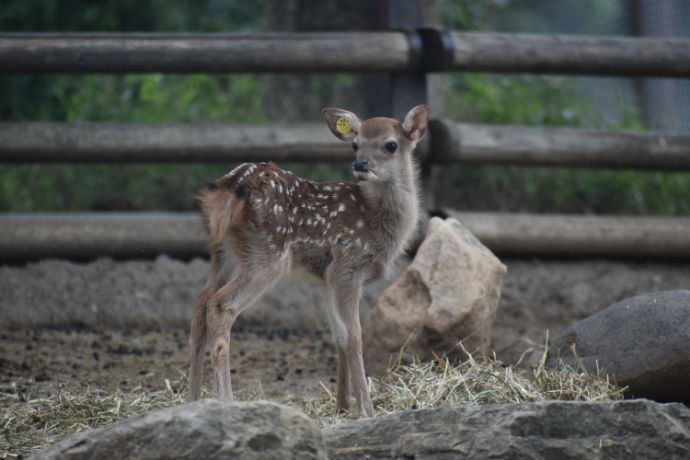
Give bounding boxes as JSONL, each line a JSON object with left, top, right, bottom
{"left": 438, "top": 0, "right": 690, "bottom": 215}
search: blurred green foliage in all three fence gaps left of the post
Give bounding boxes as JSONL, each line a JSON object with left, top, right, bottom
{"left": 0, "top": 0, "right": 266, "bottom": 211}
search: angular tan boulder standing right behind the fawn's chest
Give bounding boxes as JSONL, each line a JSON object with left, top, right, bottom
{"left": 364, "top": 217, "right": 506, "bottom": 374}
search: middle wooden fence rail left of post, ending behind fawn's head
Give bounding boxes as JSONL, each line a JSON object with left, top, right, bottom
{"left": 0, "top": 122, "right": 353, "bottom": 163}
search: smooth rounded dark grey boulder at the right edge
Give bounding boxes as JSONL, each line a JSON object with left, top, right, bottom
{"left": 549, "top": 291, "right": 690, "bottom": 403}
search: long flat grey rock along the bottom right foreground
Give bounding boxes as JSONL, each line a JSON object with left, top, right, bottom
{"left": 324, "top": 400, "right": 690, "bottom": 459}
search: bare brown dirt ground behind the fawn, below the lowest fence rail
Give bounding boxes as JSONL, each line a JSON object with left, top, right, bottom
{"left": 0, "top": 259, "right": 690, "bottom": 458}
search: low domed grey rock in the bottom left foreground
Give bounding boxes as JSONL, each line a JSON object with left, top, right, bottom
{"left": 36, "top": 400, "right": 327, "bottom": 460}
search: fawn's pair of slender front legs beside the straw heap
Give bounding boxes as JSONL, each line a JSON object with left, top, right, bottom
{"left": 329, "top": 272, "right": 374, "bottom": 417}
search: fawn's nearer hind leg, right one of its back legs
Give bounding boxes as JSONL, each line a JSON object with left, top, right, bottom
{"left": 206, "top": 258, "right": 289, "bottom": 401}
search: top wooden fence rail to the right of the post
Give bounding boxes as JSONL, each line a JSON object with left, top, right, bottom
{"left": 444, "top": 32, "right": 690, "bottom": 77}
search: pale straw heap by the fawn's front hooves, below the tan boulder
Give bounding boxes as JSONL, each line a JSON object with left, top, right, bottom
{"left": 295, "top": 353, "right": 625, "bottom": 426}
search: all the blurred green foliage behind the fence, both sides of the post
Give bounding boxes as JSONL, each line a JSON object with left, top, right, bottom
{"left": 0, "top": 0, "right": 690, "bottom": 215}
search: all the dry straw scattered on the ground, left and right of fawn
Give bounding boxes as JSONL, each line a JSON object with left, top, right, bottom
{"left": 0, "top": 354, "right": 623, "bottom": 458}
